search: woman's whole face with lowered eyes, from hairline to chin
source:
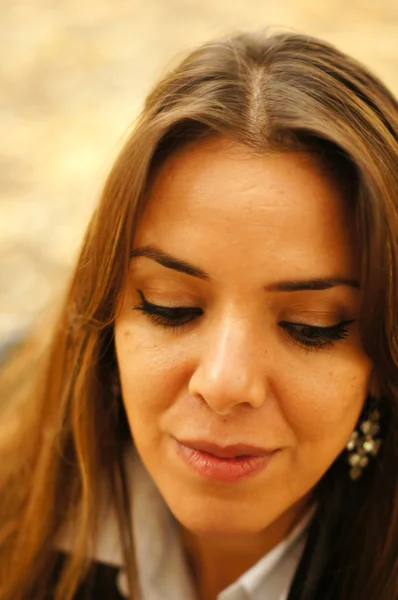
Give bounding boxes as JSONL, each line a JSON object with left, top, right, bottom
{"left": 115, "top": 139, "right": 372, "bottom": 534}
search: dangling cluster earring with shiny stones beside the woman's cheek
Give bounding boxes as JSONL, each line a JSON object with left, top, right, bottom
{"left": 346, "top": 409, "right": 381, "bottom": 481}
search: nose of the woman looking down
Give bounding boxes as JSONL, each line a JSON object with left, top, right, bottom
{"left": 189, "top": 318, "right": 267, "bottom": 415}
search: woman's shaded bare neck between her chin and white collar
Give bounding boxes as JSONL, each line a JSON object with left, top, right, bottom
{"left": 182, "top": 501, "right": 308, "bottom": 600}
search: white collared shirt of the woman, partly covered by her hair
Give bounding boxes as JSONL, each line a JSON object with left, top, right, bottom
{"left": 58, "top": 452, "right": 313, "bottom": 600}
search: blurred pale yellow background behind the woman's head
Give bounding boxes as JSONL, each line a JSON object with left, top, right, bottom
{"left": 0, "top": 0, "right": 398, "bottom": 362}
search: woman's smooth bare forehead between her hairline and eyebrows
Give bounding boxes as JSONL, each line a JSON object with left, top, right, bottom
{"left": 135, "top": 139, "right": 356, "bottom": 282}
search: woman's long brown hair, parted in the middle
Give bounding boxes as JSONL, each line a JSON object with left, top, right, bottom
{"left": 0, "top": 33, "right": 398, "bottom": 600}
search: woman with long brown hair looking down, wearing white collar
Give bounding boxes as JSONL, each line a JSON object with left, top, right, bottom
{"left": 0, "top": 29, "right": 398, "bottom": 600}
